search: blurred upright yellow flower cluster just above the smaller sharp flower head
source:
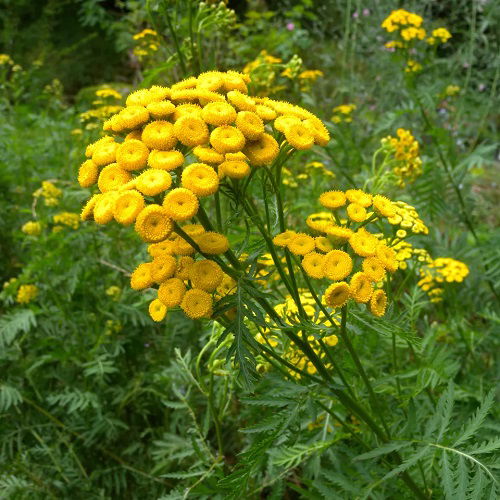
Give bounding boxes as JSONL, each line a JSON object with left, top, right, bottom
{"left": 381, "top": 128, "right": 422, "bottom": 187}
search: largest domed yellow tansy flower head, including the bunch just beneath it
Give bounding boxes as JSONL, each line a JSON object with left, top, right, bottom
{"left": 78, "top": 71, "right": 329, "bottom": 321}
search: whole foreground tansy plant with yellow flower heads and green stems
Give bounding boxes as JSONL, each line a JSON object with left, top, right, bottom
{"left": 74, "top": 71, "right": 460, "bottom": 497}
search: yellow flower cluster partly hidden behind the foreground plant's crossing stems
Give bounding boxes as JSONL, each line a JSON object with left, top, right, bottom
{"left": 255, "top": 290, "right": 339, "bottom": 379}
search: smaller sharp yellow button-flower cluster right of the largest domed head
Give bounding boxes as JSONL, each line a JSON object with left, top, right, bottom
{"left": 273, "top": 189, "right": 414, "bottom": 316}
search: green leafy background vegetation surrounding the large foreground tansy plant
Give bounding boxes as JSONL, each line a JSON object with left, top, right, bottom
{"left": 0, "top": 0, "right": 500, "bottom": 499}
